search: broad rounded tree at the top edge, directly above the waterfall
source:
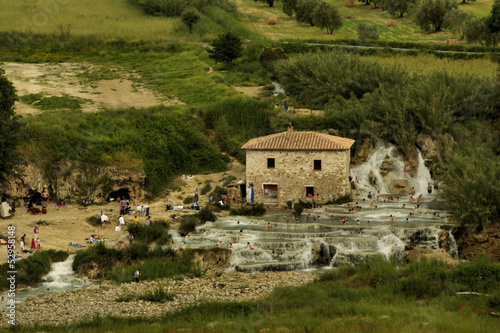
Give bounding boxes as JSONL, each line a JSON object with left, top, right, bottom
{"left": 415, "top": 0, "right": 457, "bottom": 31}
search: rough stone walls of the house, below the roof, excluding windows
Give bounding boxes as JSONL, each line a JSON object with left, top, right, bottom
{"left": 246, "top": 150, "right": 351, "bottom": 205}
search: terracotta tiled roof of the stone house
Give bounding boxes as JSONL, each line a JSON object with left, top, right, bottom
{"left": 241, "top": 131, "right": 355, "bottom": 150}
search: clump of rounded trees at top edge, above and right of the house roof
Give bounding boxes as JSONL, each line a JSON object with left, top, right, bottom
{"left": 283, "top": 0, "right": 342, "bottom": 34}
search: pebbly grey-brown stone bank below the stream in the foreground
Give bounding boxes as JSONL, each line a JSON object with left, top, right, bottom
{"left": 1, "top": 272, "right": 314, "bottom": 326}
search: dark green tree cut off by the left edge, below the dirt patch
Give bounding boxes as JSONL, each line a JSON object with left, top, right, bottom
{"left": 0, "top": 68, "right": 21, "bottom": 184}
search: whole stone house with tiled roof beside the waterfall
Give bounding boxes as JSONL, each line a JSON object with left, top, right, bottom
{"left": 241, "top": 124, "right": 354, "bottom": 205}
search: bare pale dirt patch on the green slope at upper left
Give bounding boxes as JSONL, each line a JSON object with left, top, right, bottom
{"left": 0, "top": 63, "right": 181, "bottom": 114}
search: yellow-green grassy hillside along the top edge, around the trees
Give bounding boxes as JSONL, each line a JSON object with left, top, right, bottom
{"left": 0, "top": 0, "right": 493, "bottom": 42}
